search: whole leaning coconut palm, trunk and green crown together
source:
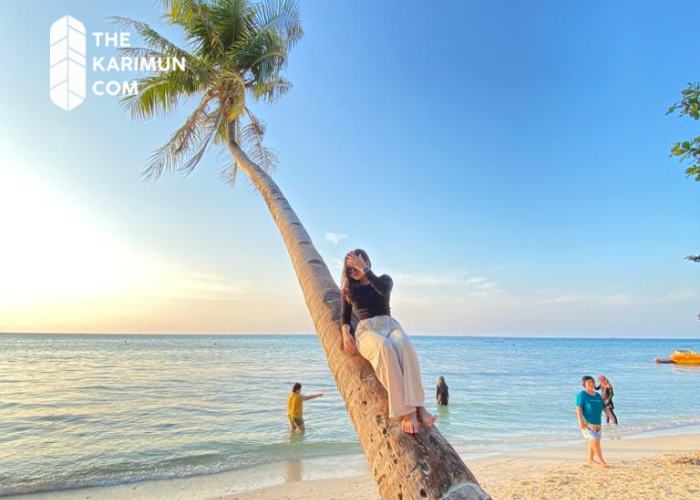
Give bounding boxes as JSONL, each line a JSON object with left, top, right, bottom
{"left": 112, "top": 0, "right": 489, "bottom": 500}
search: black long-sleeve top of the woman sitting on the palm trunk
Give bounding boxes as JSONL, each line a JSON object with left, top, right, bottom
{"left": 340, "top": 271, "right": 394, "bottom": 335}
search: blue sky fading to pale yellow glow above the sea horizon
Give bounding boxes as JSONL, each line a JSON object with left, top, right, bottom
{"left": 0, "top": 0, "right": 700, "bottom": 337}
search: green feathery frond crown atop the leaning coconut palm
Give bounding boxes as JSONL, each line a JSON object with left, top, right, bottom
{"left": 110, "top": 0, "right": 303, "bottom": 183}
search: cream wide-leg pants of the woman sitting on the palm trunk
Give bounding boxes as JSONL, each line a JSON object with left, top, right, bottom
{"left": 355, "top": 316, "right": 425, "bottom": 418}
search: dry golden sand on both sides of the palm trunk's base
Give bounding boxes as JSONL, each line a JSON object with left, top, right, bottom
{"left": 228, "top": 433, "right": 700, "bottom": 500}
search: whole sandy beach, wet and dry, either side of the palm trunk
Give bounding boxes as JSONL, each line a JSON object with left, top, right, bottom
{"left": 8, "top": 427, "right": 700, "bottom": 500}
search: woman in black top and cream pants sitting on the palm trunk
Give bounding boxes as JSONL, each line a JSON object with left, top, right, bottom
{"left": 341, "top": 249, "right": 437, "bottom": 434}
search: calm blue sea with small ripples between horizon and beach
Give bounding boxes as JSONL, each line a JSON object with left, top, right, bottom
{"left": 0, "top": 334, "right": 700, "bottom": 496}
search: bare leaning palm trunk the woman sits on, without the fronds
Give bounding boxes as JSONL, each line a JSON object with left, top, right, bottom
{"left": 228, "top": 137, "right": 490, "bottom": 500}
